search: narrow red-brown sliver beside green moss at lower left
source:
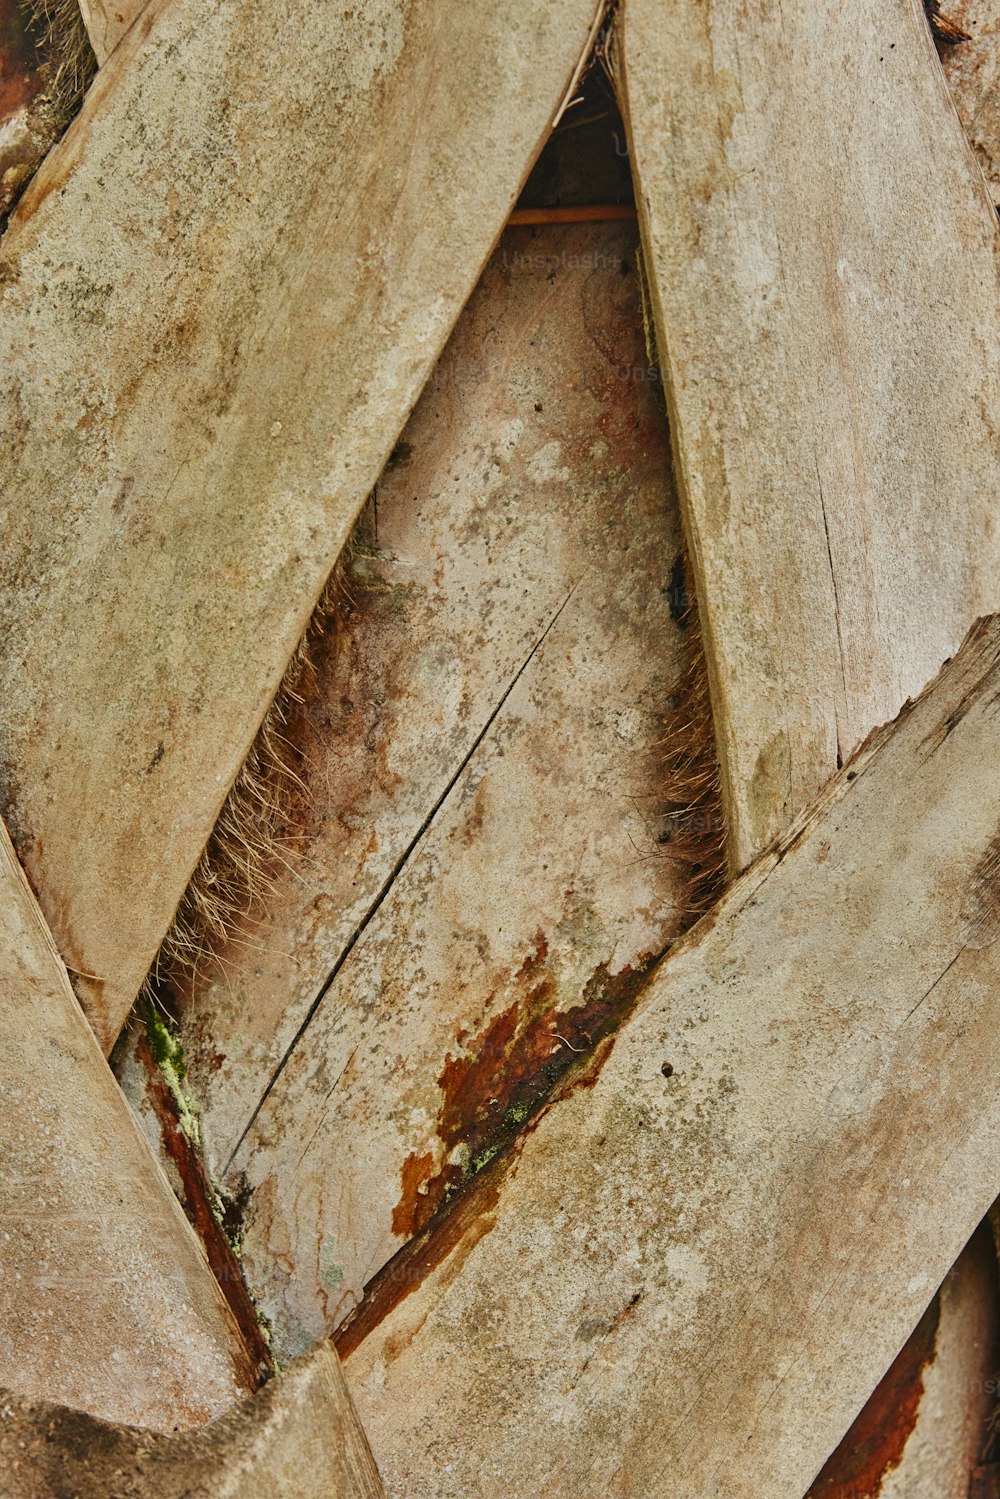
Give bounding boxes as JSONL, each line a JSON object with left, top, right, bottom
{"left": 136, "top": 1036, "right": 274, "bottom": 1390}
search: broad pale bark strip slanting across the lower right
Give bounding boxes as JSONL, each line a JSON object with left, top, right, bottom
{"left": 348, "top": 619, "right": 1000, "bottom": 1499}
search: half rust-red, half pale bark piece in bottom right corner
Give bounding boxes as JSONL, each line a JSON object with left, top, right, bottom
{"left": 808, "top": 1223, "right": 1000, "bottom": 1499}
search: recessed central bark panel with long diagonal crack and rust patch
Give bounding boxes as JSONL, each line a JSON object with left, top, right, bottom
{"left": 142, "top": 225, "right": 687, "bottom": 1358}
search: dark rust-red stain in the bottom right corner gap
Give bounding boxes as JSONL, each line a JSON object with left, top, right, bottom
{"left": 807, "top": 1295, "right": 940, "bottom": 1499}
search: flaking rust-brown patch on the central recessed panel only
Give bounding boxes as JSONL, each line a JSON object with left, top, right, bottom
{"left": 393, "top": 932, "right": 660, "bottom": 1238}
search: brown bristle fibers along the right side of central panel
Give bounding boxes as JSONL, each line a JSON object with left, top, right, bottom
{"left": 663, "top": 556, "right": 729, "bottom": 928}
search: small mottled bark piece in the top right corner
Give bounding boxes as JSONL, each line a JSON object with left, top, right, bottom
{"left": 942, "top": 0, "right": 1000, "bottom": 204}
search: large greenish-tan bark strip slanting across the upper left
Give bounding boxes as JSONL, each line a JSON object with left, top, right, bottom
{"left": 0, "top": 0, "right": 605, "bottom": 1048}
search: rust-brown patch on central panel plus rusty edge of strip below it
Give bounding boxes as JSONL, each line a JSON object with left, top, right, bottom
{"left": 334, "top": 932, "right": 663, "bottom": 1358}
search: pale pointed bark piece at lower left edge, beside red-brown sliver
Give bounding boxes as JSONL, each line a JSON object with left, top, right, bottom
{"left": 0, "top": 826, "right": 252, "bottom": 1430}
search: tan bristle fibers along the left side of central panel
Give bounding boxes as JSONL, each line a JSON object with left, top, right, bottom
{"left": 141, "top": 507, "right": 370, "bottom": 1004}
